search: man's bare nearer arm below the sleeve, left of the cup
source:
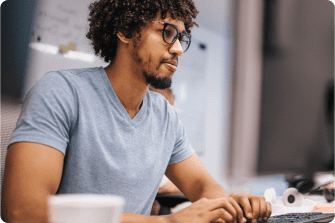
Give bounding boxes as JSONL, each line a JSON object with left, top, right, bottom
{"left": 1, "top": 142, "right": 64, "bottom": 222}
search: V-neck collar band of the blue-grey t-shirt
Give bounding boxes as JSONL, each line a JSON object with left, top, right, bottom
{"left": 100, "top": 67, "right": 148, "bottom": 127}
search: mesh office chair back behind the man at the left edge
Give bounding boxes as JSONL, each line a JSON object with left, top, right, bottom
{"left": 0, "top": 98, "right": 22, "bottom": 223}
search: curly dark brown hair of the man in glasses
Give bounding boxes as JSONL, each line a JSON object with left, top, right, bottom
{"left": 86, "top": 0, "right": 199, "bottom": 63}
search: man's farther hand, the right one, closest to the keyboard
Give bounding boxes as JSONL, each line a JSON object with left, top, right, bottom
{"left": 229, "top": 193, "right": 272, "bottom": 223}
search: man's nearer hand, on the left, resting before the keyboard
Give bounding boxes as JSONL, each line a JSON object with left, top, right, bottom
{"left": 166, "top": 197, "right": 247, "bottom": 223}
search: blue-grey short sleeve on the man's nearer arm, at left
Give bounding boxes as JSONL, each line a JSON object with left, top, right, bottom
{"left": 9, "top": 72, "right": 77, "bottom": 154}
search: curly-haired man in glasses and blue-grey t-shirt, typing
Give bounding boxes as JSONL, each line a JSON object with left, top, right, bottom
{"left": 2, "top": 0, "right": 271, "bottom": 223}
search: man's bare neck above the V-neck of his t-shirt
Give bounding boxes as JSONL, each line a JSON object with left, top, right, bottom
{"left": 105, "top": 61, "right": 148, "bottom": 119}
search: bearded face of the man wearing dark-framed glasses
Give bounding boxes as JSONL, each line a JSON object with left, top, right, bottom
{"left": 133, "top": 13, "right": 185, "bottom": 89}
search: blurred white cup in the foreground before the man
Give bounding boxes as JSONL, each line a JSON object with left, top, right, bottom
{"left": 48, "top": 194, "right": 125, "bottom": 223}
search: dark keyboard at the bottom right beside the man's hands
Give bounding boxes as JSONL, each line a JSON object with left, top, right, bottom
{"left": 252, "top": 212, "right": 335, "bottom": 223}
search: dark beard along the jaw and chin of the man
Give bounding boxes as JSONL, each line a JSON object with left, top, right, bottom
{"left": 133, "top": 40, "right": 172, "bottom": 89}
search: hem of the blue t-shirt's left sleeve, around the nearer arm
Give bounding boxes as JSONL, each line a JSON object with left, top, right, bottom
{"left": 7, "top": 136, "right": 67, "bottom": 155}
